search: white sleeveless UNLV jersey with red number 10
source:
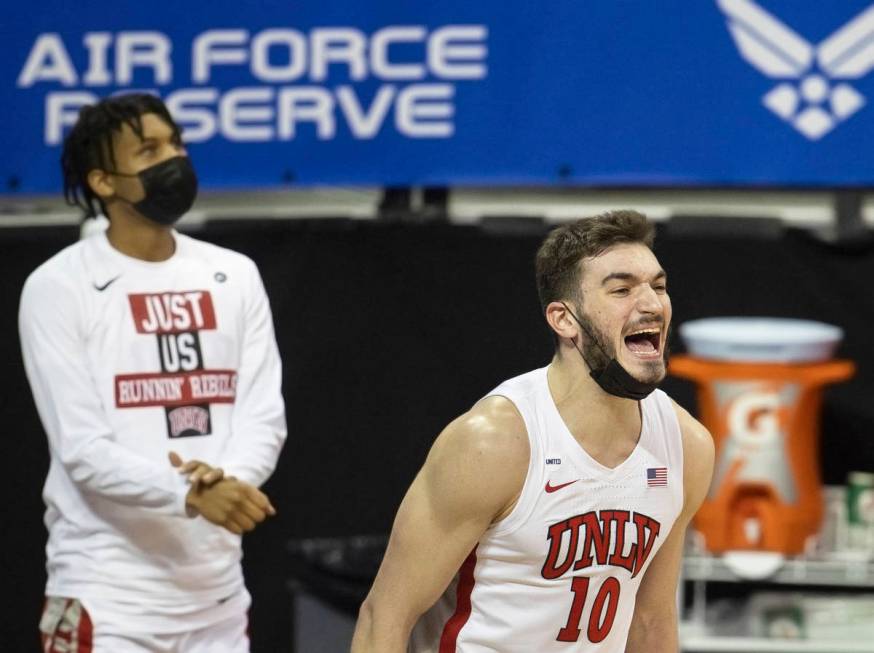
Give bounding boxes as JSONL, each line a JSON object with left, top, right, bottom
{"left": 409, "top": 368, "right": 683, "bottom": 653}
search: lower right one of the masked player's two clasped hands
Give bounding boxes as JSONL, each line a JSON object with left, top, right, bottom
{"left": 185, "top": 476, "right": 276, "bottom": 535}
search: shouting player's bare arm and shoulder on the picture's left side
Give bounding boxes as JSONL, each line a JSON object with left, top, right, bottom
{"left": 352, "top": 397, "right": 529, "bottom": 653}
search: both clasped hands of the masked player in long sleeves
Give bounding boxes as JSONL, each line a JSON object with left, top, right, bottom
{"left": 170, "top": 451, "right": 276, "bottom": 535}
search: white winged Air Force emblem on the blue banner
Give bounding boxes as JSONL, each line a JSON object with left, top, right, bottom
{"left": 717, "top": 0, "right": 874, "bottom": 141}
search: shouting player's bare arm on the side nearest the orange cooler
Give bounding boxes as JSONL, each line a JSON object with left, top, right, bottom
{"left": 625, "top": 404, "right": 714, "bottom": 653}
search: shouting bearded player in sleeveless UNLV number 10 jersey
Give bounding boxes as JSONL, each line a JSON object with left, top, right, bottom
{"left": 352, "top": 211, "right": 713, "bottom": 653}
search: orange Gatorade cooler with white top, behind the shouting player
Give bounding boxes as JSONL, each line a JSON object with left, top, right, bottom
{"left": 669, "top": 318, "right": 855, "bottom": 555}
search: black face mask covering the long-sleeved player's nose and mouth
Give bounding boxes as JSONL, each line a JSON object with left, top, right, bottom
{"left": 113, "top": 156, "right": 197, "bottom": 226}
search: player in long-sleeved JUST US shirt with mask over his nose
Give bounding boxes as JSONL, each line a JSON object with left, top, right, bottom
{"left": 19, "top": 94, "right": 285, "bottom": 653}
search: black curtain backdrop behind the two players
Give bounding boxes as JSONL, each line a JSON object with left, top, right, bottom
{"left": 0, "top": 219, "right": 874, "bottom": 653}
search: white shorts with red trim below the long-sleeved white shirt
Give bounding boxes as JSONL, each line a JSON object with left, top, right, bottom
{"left": 39, "top": 596, "right": 249, "bottom": 653}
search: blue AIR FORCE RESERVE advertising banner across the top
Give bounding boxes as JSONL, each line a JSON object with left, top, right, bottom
{"left": 0, "top": 0, "right": 874, "bottom": 194}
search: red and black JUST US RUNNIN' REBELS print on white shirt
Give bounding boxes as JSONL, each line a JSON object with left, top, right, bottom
{"left": 115, "top": 290, "right": 237, "bottom": 438}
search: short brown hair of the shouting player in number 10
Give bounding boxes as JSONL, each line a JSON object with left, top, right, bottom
{"left": 535, "top": 210, "right": 655, "bottom": 310}
